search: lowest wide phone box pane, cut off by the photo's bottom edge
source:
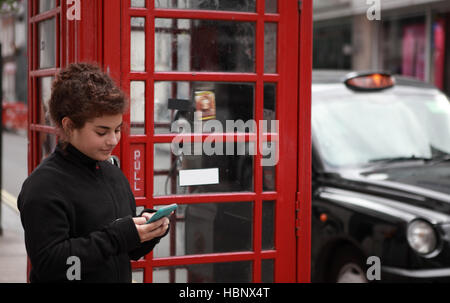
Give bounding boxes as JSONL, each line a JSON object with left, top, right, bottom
{"left": 153, "top": 261, "right": 253, "bottom": 283}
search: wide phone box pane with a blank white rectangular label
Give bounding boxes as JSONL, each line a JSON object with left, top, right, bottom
{"left": 153, "top": 142, "right": 255, "bottom": 196}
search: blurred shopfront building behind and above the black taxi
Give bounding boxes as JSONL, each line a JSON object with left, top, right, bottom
{"left": 313, "top": 0, "right": 450, "bottom": 95}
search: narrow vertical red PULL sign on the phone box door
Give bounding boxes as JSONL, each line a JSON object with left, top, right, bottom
{"left": 131, "top": 144, "right": 145, "bottom": 197}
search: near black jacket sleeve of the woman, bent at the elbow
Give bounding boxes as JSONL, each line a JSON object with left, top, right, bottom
{"left": 18, "top": 188, "right": 140, "bottom": 281}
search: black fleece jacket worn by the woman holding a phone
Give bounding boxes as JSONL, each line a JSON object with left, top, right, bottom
{"left": 17, "top": 144, "right": 167, "bottom": 282}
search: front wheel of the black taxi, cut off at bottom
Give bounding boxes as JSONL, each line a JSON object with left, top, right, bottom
{"left": 328, "top": 247, "right": 368, "bottom": 283}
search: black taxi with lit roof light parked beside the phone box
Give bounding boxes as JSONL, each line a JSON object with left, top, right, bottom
{"left": 311, "top": 71, "right": 450, "bottom": 282}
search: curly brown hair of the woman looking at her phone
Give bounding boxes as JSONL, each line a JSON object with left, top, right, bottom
{"left": 49, "top": 63, "right": 128, "bottom": 130}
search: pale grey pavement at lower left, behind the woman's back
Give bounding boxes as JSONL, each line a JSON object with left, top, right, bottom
{"left": 0, "top": 192, "right": 27, "bottom": 283}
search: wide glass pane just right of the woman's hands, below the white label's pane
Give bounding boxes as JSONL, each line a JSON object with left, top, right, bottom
{"left": 153, "top": 202, "right": 253, "bottom": 258}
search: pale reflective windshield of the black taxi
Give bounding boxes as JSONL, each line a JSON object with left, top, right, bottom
{"left": 311, "top": 87, "right": 450, "bottom": 167}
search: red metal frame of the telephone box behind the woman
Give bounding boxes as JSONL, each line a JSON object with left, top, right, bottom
{"left": 28, "top": 0, "right": 312, "bottom": 282}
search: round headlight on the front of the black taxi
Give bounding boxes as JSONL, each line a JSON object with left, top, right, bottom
{"left": 407, "top": 220, "right": 437, "bottom": 255}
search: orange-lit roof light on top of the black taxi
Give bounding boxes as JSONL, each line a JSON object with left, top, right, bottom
{"left": 345, "top": 73, "right": 395, "bottom": 91}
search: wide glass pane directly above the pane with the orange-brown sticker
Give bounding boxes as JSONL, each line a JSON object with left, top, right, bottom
{"left": 155, "top": 18, "right": 255, "bottom": 72}
